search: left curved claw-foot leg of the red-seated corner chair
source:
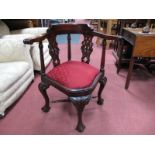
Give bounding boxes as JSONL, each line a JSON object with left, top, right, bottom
{"left": 38, "top": 82, "right": 50, "bottom": 112}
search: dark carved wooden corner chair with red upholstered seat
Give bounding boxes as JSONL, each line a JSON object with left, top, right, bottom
{"left": 24, "top": 24, "right": 118, "bottom": 132}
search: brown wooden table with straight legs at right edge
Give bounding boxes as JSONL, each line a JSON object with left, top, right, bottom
{"left": 117, "top": 28, "right": 155, "bottom": 89}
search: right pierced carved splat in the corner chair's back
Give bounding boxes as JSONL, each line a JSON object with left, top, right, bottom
{"left": 81, "top": 35, "right": 93, "bottom": 64}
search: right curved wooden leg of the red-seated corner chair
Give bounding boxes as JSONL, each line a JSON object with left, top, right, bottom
{"left": 97, "top": 77, "right": 107, "bottom": 105}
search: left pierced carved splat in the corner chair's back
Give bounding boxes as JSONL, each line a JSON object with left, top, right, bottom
{"left": 48, "top": 36, "right": 60, "bottom": 67}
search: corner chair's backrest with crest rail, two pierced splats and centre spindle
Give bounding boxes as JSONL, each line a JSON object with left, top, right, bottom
{"left": 47, "top": 24, "right": 93, "bottom": 67}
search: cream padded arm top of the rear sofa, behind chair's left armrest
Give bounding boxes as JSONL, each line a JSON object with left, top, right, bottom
{"left": 10, "top": 27, "right": 47, "bottom": 35}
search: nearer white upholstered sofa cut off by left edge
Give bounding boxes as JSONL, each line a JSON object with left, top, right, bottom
{"left": 0, "top": 38, "right": 34, "bottom": 116}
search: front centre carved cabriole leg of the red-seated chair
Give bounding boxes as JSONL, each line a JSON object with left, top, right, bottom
{"left": 70, "top": 95, "right": 91, "bottom": 132}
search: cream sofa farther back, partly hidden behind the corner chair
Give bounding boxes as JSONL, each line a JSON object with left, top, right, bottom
{"left": 0, "top": 20, "right": 51, "bottom": 71}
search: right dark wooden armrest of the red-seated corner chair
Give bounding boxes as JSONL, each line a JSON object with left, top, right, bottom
{"left": 93, "top": 31, "right": 122, "bottom": 40}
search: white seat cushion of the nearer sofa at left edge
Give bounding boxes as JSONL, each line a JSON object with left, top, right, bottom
{"left": 0, "top": 61, "right": 30, "bottom": 93}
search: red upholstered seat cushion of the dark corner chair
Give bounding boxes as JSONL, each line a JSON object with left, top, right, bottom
{"left": 48, "top": 61, "right": 99, "bottom": 88}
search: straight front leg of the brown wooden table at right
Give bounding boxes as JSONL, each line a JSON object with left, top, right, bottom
{"left": 125, "top": 57, "right": 135, "bottom": 89}
